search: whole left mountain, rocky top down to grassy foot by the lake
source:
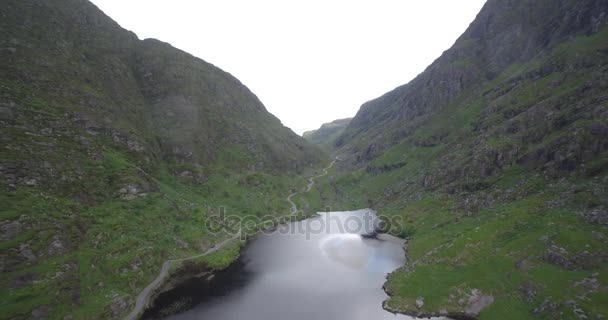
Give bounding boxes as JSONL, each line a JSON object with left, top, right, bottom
{"left": 0, "top": 0, "right": 327, "bottom": 319}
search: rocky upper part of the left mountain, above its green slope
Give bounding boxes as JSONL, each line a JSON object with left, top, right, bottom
{"left": 0, "top": 0, "right": 323, "bottom": 185}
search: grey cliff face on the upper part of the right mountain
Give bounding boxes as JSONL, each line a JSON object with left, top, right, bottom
{"left": 337, "top": 1, "right": 608, "bottom": 170}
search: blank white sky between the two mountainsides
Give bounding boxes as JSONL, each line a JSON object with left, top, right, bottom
{"left": 92, "top": 0, "right": 485, "bottom": 134}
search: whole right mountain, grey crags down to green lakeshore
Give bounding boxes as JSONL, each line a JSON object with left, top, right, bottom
{"left": 312, "top": 0, "right": 608, "bottom": 319}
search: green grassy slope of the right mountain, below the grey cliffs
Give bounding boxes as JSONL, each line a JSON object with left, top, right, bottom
{"left": 311, "top": 29, "right": 608, "bottom": 319}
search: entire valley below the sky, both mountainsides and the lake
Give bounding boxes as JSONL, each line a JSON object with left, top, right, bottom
{"left": 0, "top": 0, "right": 608, "bottom": 320}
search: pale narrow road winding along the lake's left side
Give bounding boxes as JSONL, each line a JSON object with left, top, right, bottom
{"left": 125, "top": 160, "right": 336, "bottom": 320}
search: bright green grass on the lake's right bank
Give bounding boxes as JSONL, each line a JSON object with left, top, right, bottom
{"left": 308, "top": 167, "right": 608, "bottom": 319}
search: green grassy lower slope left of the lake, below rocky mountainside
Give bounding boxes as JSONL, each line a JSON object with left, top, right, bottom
{"left": 0, "top": 134, "right": 318, "bottom": 319}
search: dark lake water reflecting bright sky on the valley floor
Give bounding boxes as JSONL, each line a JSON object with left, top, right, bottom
{"left": 146, "top": 210, "right": 444, "bottom": 320}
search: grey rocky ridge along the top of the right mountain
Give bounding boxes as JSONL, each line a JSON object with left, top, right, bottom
{"left": 338, "top": 1, "right": 607, "bottom": 161}
